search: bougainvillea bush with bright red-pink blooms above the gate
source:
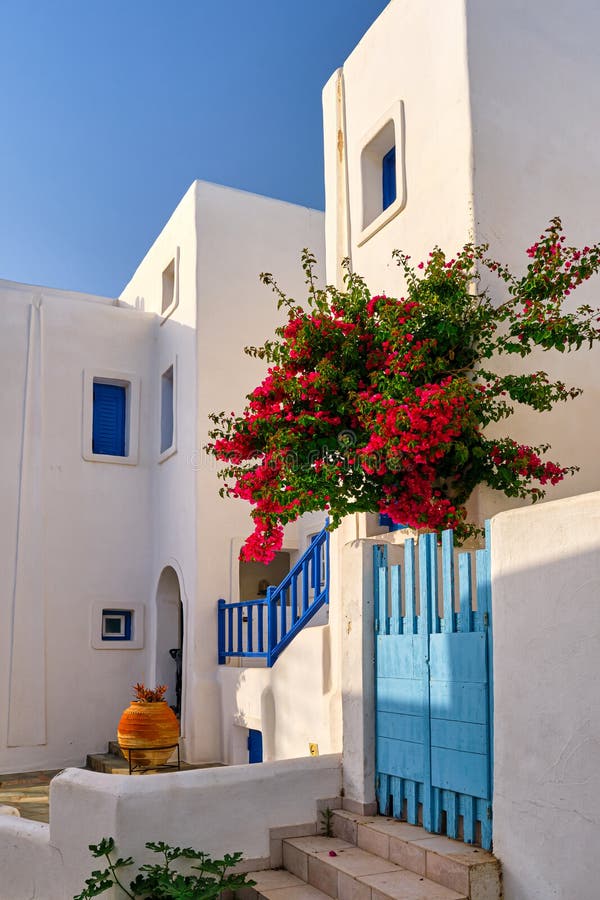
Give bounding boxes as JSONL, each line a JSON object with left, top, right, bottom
{"left": 208, "top": 219, "right": 600, "bottom": 562}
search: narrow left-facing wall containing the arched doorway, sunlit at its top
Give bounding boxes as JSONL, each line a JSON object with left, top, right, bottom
{"left": 120, "top": 185, "right": 199, "bottom": 759}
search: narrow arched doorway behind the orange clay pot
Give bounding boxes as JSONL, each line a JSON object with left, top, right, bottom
{"left": 156, "top": 566, "right": 183, "bottom": 715}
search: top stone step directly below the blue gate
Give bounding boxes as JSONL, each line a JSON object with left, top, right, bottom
{"left": 332, "top": 810, "right": 502, "bottom": 900}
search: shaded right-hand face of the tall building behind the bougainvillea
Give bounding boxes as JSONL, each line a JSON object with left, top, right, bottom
{"left": 466, "top": 0, "right": 600, "bottom": 518}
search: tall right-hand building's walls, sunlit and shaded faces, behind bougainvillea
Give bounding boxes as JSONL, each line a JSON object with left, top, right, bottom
{"left": 323, "top": 0, "right": 600, "bottom": 521}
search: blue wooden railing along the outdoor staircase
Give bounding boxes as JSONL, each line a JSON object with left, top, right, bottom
{"left": 217, "top": 528, "right": 329, "bottom": 666}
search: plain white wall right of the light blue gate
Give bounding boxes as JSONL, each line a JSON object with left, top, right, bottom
{"left": 491, "top": 493, "right": 600, "bottom": 900}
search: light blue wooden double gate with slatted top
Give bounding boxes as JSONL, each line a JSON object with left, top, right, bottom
{"left": 374, "top": 527, "right": 493, "bottom": 849}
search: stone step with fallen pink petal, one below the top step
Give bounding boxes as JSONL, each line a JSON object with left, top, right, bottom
{"left": 278, "top": 835, "right": 468, "bottom": 900}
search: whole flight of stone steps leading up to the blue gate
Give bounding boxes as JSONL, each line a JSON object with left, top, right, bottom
{"left": 242, "top": 810, "right": 502, "bottom": 900}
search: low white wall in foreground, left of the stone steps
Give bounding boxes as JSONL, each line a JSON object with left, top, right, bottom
{"left": 0, "top": 754, "right": 341, "bottom": 900}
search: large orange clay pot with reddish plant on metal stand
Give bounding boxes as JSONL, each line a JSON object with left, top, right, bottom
{"left": 117, "top": 682, "right": 179, "bottom": 768}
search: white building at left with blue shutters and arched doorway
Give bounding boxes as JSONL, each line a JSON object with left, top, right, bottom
{"left": 0, "top": 182, "right": 324, "bottom": 772}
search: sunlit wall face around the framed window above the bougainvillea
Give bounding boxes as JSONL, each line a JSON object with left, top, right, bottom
{"left": 323, "top": 0, "right": 473, "bottom": 294}
